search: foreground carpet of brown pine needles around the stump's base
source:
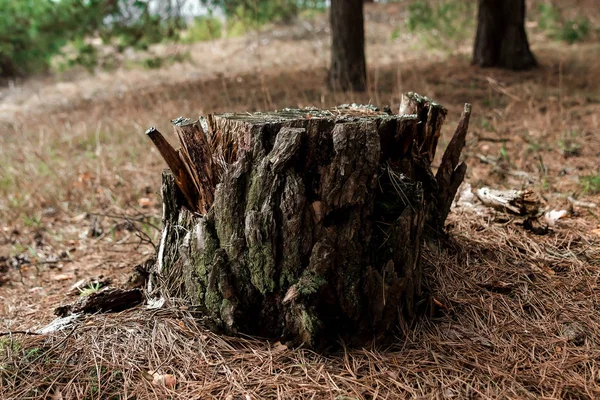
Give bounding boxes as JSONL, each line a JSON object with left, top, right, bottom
{"left": 0, "top": 209, "right": 600, "bottom": 400}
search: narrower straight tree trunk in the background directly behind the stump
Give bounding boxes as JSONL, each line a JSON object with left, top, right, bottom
{"left": 329, "top": 0, "right": 367, "bottom": 91}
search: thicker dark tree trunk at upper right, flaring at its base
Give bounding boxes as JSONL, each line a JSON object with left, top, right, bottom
{"left": 473, "top": 0, "right": 537, "bottom": 70}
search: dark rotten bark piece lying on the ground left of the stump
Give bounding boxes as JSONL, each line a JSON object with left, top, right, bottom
{"left": 54, "top": 287, "right": 142, "bottom": 317}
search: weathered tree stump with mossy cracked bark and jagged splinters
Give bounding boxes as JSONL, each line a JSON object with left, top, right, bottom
{"left": 147, "top": 93, "right": 470, "bottom": 348}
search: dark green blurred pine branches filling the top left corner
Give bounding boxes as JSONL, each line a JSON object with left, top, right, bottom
{"left": 0, "top": 0, "right": 183, "bottom": 76}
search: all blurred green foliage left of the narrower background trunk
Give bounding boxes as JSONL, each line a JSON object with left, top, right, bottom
{"left": 0, "top": 0, "right": 327, "bottom": 77}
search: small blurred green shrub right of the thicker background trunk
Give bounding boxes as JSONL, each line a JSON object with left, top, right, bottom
{"left": 538, "top": 3, "right": 590, "bottom": 44}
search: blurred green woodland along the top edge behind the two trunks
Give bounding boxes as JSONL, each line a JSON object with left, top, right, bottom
{"left": 0, "top": 0, "right": 598, "bottom": 78}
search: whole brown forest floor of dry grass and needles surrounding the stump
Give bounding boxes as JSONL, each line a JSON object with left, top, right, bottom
{"left": 0, "top": 2, "right": 600, "bottom": 400}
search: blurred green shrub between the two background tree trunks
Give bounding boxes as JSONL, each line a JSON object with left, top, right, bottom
{"left": 392, "top": 0, "right": 475, "bottom": 47}
